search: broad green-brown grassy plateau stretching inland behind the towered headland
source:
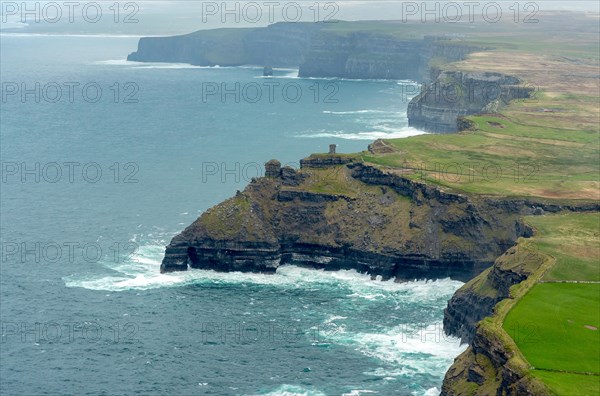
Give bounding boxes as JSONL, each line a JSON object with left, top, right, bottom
{"left": 364, "top": 31, "right": 600, "bottom": 200}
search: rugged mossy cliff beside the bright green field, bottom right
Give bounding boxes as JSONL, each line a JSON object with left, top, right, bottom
{"left": 441, "top": 243, "right": 549, "bottom": 396}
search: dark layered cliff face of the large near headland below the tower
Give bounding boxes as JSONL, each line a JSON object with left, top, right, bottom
{"left": 161, "top": 155, "right": 552, "bottom": 280}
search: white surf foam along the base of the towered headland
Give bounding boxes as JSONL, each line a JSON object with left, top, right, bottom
{"left": 64, "top": 237, "right": 462, "bottom": 296}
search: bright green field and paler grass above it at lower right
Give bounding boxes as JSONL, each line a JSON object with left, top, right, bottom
{"left": 502, "top": 213, "right": 600, "bottom": 395}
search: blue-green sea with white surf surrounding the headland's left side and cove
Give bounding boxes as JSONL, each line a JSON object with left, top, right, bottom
{"left": 0, "top": 34, "right": 464, "bottom": 395}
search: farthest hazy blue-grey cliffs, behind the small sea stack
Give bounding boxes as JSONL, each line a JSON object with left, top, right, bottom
{"left": 127, "top": 23, "right": 481, "bottom": 81}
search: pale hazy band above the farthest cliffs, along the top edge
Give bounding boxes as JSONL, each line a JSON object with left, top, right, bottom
{"left": 0, "top": 0, "right": 600, "bottom": 35}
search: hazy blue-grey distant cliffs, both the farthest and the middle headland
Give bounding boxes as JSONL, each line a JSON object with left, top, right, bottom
{"left": 127, "top": 23, "right": 496, "bottom": 132}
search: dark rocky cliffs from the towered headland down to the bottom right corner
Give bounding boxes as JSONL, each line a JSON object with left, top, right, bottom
{"left": 161, "top": 154, "right": 600, "bottom": 395}
